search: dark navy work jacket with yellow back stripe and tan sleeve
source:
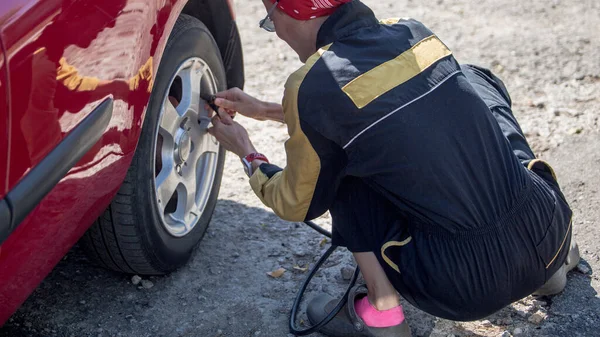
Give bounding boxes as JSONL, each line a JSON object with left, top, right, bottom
{"left": 250, "top": 1, "right": 564, "bottom": 233}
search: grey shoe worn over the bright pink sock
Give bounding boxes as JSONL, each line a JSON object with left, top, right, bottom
{"left": 306, "top": 285, "right": 412, "bottom": 337}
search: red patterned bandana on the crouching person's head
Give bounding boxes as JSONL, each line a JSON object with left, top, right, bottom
{"left": 271, "top": 0, "right": 352, "bottom": 21}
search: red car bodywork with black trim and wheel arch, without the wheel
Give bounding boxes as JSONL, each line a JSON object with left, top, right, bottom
{"left": 0, "top": 0, "right": 244, "bottom": 325}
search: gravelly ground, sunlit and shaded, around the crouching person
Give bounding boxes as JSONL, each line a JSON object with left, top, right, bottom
{"left": 0, "top": 0, "right": 600, "bottom": 336}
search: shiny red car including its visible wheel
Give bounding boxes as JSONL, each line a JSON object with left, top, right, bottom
{"left": 0, "top": 0, "right": 244, "bottom": 325}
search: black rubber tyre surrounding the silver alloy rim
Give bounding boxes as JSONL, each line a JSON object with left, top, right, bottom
{"left": 82, "top": 14, "right": 227, "bottom": 275}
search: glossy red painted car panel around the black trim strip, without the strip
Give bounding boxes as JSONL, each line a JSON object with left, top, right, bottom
{"left": 0, "top": 0, "right": 180, "bottom": 324}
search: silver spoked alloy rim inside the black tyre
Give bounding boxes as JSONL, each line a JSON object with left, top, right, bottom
{"left": 153, "top": 57, "right": 219, "bottom": 237}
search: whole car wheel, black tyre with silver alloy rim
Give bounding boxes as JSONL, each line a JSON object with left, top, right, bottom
{"left": 82, "top": 14, "right": 226, "bottom": 275}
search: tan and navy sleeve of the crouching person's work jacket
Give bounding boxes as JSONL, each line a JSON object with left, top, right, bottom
{"left": 250, "top": 75, "right": 347, "bottom": 221}
